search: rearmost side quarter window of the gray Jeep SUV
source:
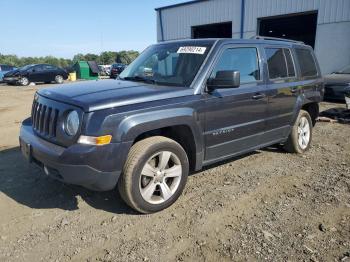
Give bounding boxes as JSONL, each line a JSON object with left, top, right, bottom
{"left": 295, "top": 48, "right": 317, "bottom": 77}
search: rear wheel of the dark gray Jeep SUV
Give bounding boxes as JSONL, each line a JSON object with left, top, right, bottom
{"left": 283, "top": 110, "right": 313, "bottom": 154}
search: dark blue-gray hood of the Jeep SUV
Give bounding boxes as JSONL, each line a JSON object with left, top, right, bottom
{"left": 38, "top": 80, "right": 193, "bottom": 112}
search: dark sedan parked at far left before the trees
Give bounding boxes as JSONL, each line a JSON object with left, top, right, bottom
{"left": 3, "top": 64, "right": 68, "bottom": 86}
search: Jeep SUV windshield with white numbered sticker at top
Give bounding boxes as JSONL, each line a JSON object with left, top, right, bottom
{"left": 119, "top": 41, "right": 213, "bottom": 87}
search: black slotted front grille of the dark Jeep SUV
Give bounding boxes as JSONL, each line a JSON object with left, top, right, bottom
{"left": 32, "top": 101, "right": 59, "bottom": 138}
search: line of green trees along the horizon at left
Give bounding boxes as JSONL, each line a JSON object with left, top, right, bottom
{"left": 0, "top": 50, "right": 139, "bottom": 68}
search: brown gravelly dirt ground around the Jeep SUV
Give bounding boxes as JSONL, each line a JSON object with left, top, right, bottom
{"left": 0, "top": 83, "right": 350, "bottom": 261}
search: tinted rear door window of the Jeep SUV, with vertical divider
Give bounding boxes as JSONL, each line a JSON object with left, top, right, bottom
{"left": 265, "top": 48, "right": 295, "bottom": 79}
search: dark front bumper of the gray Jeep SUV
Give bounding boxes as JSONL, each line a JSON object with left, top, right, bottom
{"left": 19, "top": 120, "right": 131, "bottom": 191}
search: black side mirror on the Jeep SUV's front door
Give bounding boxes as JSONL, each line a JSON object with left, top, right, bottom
{"left": 207, "top": 71, "right": 241, "bottom": 90}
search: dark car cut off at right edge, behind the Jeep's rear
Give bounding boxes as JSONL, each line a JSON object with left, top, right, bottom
{"left": 324, "top": 65, "right": 350, "bottom": 102}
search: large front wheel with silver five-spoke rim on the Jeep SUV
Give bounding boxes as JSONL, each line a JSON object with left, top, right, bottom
{"left": 118, "top": 136, "right": 189, "bottom": 213}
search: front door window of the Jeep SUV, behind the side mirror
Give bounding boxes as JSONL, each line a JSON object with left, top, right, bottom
{"left": 210, "top": 47, "right": 260, "bottom": 84}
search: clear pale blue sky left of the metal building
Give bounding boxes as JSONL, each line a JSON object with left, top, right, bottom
{"left": 0, "top": 0, "right": 186, "bottom": 58}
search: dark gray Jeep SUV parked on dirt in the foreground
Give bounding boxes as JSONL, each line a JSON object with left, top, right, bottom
{"left": 20, "top": 36, "right": 324, "bottom": 213}
